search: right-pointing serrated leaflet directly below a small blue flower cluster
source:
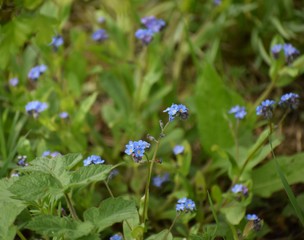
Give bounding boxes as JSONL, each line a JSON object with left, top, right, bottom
{"left": 69, "top": 164, "right": 113, "bottom": 187}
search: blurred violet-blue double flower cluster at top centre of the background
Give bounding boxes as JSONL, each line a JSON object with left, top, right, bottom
{"left": 135, "top": 16, "right": 166, "bottom": 45}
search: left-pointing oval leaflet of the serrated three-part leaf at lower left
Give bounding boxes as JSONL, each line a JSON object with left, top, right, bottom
{"left": 9, "top": 172, "right": 64, "bottom": 201}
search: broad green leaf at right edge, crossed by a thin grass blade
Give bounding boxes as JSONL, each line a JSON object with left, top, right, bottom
{"left": 252, "top": 153, "right": 304, "bottom": 197}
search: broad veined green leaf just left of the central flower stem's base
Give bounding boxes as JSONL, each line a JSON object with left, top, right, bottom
{"left": 83, "top": 197, "right": 138, "bottom": 231}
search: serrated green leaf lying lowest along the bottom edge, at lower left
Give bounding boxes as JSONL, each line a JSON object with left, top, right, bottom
{"left": 26, "top": 215, "right": 94, "bottom": 239}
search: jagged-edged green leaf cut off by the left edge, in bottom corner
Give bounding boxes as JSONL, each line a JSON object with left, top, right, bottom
{"left": 0, "top": 178, "right": 26, "bottom": 240}
